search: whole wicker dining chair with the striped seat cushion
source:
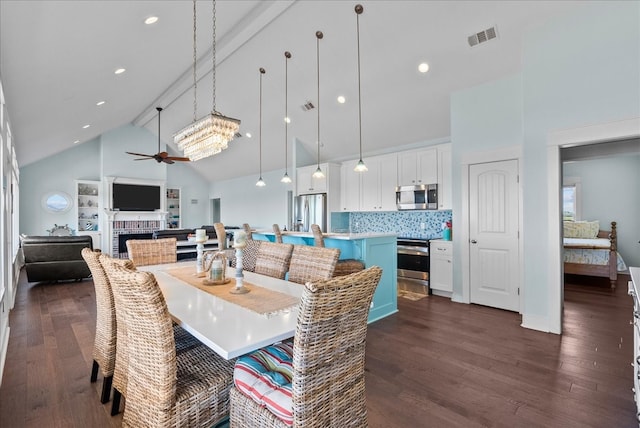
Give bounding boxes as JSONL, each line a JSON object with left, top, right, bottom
{"left": 230, "top": 266, "right": 382, "bottom": 428}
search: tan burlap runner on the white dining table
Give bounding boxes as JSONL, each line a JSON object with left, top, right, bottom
{"left": 165, "top": 266, "right": 300, "bottom": 315}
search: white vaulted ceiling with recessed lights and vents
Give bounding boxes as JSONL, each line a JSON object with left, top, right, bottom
{"left": 0, "top": 0, "right": 585, "bottom": 180}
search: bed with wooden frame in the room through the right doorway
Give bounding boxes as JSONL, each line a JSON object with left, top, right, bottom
{"left": 563, "top": 221, "right": 625, "bottom": 289}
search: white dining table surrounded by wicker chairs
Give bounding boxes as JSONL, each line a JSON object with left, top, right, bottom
{"left": 138, "top": 262, "right": 304, "bottom": 360}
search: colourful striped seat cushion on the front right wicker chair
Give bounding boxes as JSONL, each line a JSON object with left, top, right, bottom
{"left": 233, "top": 343, "right": 293, "bottom": 425}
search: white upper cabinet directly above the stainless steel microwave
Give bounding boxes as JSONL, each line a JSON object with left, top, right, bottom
{"left": 398, "top": 148, "right": 438, "bottom": 186}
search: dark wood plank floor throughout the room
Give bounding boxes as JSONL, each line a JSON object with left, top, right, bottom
{"left": 0, "top": 270, "right": 638, "bottom": 428}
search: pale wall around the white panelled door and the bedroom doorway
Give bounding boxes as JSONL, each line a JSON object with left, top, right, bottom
{"left": 451, "top": 1, "right": 640, "bottom": 332}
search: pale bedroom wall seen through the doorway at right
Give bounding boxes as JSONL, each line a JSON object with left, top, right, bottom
{"left": 563, "top": 154, "right": 640, "bottom": 266}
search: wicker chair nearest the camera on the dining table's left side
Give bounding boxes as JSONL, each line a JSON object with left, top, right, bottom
{"left": 100, "top": 257, "right": 234, "bottom": 427}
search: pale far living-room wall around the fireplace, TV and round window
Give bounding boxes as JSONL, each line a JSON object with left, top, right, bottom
{"left": 20, "top": 124, "right": 210, "bottom": 235}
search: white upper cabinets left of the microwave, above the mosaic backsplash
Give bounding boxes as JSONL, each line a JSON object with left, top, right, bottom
{"left": 341, "top": 153, "right": 398, "bottom": 211}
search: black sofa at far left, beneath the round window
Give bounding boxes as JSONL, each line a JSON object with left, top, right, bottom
{"left": 22, "top": 236, "right": 93, "bottom": 282}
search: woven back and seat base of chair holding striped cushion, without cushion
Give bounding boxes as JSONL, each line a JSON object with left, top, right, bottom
{"left": 230, "top": 266, "right": 382, "bottom": 428}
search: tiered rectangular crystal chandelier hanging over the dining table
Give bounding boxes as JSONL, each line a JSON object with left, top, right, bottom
{"left": 173, "top": 0, "right": 240, "bottom": 161}
